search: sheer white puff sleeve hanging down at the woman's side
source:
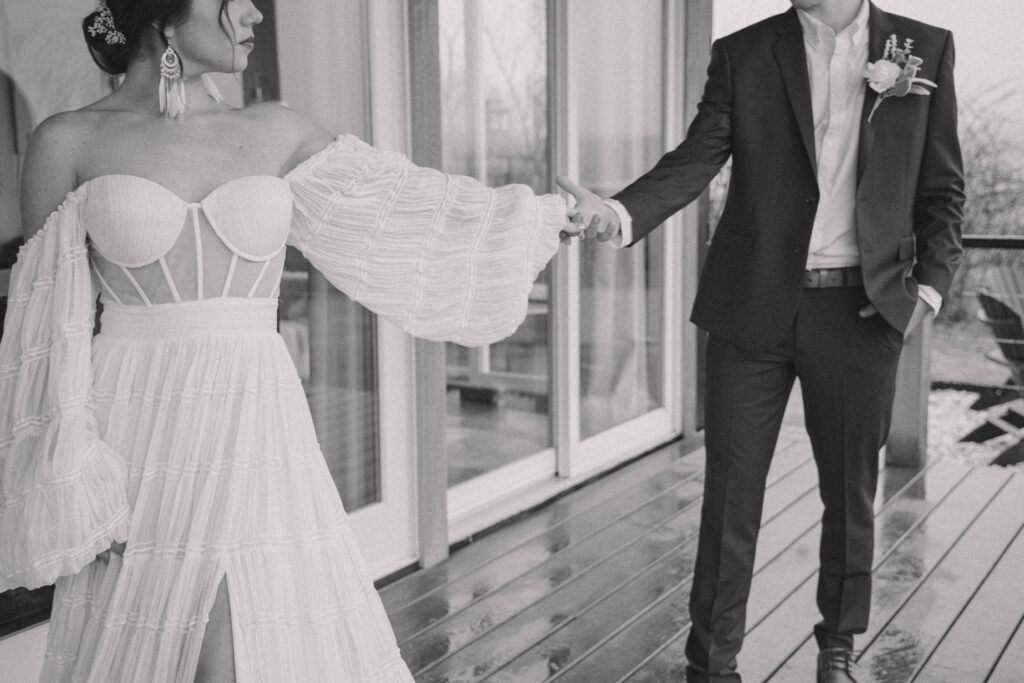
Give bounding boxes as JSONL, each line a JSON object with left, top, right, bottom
{"left": 0, "top": 193, "right": 128, "bottom": 591}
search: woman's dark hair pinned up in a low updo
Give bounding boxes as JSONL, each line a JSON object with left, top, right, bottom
{"left": 82, "top": 0, "right": 230, "bottom": 76}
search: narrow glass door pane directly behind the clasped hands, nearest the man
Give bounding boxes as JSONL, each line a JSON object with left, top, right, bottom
{"left": 568, "top": 0, "right": 666, "bottom": 439}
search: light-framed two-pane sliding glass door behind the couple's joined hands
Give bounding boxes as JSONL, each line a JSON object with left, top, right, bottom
{"left": 428, "top": 0, "right": 679, "bottom": 540}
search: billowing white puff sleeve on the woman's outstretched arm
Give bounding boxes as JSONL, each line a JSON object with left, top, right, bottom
{"left": 287, "top": 135, "right": 565, "bottom": 346}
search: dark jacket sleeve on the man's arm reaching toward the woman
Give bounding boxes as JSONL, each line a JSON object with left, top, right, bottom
{"left": 613, "top": 41, "right": 732, "bottom": 242}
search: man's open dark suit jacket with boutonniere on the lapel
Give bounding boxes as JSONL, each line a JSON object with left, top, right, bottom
{"left": 614, "top": 5, "right": 964, "bottom": 350}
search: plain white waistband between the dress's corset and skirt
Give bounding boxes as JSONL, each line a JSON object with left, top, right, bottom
{"left": 99, "top": 297, "right": 278, "bottom": 338}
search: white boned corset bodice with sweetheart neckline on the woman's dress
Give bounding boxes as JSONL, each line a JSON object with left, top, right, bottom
{"left": 82, "top": 175, "right": 292, "bottom": 306}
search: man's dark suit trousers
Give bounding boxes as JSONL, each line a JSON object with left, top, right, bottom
{"left": 686, "top": 287, "right": 903, "bottom": 682}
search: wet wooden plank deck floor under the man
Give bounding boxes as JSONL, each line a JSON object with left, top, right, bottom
{"left": 382, "top": 397, "right": 1024, "bottom": 683}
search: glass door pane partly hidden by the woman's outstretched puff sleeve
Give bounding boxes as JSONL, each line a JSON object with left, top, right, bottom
{"left": 438, "top": 0, "right": 554, "bottom": 486}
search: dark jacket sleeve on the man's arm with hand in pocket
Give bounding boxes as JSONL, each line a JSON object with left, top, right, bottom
{"left": 913, "top": 33, "right": 965, "bottom": 298}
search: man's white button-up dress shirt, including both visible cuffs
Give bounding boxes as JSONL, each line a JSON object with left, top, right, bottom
{"left": 605, "top": 0, "right": 942, "bottom": 312}
